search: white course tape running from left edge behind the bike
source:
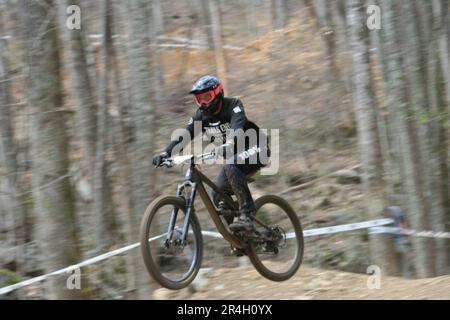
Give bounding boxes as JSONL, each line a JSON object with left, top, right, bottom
{"left": 0, "top": 219, "right": 430, "bottom": 295}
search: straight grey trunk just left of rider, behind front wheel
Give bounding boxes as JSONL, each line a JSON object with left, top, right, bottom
{"left": 127, "top": 0, "right": 154, "bottom": 299}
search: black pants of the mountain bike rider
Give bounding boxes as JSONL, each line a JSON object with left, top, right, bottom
{"left": 214, "top": 164, "right": 262, "bottom": 214}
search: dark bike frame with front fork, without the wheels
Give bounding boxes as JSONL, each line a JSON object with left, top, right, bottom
{"left": 166, "top": 157, "right": 245, "bottom": 249}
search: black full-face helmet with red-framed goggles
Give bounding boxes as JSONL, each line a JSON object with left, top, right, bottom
{"left": 189, "top": 76, "right": 223, "bottom": 115}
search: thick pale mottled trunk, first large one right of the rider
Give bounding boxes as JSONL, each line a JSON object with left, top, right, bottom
{"left": 347, "top": 0, "right": 397, "bottom": 275}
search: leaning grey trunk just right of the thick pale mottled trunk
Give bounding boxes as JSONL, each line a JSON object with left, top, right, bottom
{"left": 382, "top": 0, "right": 433, "bottom": 277}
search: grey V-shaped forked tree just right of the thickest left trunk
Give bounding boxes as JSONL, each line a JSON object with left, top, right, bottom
{"left": 57, "top": 0, "right": 112, "bottom": 287}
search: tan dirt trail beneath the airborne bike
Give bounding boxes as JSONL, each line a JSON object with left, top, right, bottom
{"left": 154, "top": 266, "right": 450, "bottom": 300}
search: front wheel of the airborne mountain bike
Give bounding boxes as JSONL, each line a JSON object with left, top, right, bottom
{"left": 140, "top": 196, "right": 203, "bottom": 290}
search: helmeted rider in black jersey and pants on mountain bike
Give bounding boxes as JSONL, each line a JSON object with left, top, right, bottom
{"left": 153, "top": 76, "right": 270, "bottom": 231}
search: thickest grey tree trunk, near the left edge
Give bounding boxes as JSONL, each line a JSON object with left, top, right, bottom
{"left": 26, "top": 0, "right": 86, "bottom": 299}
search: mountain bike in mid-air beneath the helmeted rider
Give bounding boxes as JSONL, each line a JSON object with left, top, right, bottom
{"left": 140, "top": 151, "right": 303, "bottom": 290}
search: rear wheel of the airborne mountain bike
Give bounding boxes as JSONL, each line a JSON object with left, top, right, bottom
{"left": 247, "top": 195, "right": 304, "bottom": 281}
